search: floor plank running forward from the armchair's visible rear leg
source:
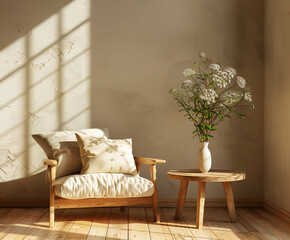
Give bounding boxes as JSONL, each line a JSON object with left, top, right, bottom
{"left": 107, "top": 208, "right": 128, "bottom": 240}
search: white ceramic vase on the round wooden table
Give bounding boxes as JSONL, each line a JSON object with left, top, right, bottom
{"left": 197, "top": 142, "right": 211, "bottom": 173}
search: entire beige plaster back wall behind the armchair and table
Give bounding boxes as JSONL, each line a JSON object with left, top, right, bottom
{"left": 0, "top": 0, "right": 264, "bottom": 201}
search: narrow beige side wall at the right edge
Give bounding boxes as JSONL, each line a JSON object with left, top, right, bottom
{"left": 264, "top": 0, "right": 290, "bottom": 211}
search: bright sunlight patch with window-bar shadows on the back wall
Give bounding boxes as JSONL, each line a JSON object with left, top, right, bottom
{"left": 0, "top": 0, "right": 91, "bottom": 182}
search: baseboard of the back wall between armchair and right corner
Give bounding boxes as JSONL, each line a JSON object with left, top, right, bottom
{"left": 159, "top": 198, "right": 263, "bottom": 207}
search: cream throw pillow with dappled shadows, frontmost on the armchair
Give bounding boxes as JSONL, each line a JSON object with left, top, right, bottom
{"left": 76, "top": 133, "right": 137, "bottom": 175}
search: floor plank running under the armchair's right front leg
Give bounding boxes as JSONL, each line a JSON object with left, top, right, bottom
{"left": 145, "top": 208, "right": 174, "bottom": 240}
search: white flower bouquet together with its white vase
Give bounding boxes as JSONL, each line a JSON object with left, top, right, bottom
{"left": 170, "top": 53, "right": 254, "bottom": 172}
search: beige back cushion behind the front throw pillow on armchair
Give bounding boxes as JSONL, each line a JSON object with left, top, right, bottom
{"left": 32, "top": 128, "right": 109, "bottom": 178}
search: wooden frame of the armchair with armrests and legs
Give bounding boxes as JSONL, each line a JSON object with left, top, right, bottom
{"left": 44, "top": 157, "right": 166, "bottom": 228}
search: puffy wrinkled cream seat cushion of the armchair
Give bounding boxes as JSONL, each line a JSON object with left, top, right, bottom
{"left": 55, "top": 173, "right": 154, "bottom": 199}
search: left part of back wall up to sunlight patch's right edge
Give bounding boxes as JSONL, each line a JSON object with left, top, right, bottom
{"left": 0, "top": 0, "right": 94, "bottom": 202}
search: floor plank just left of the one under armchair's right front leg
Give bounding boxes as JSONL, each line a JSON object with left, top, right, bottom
{"left": 129, "top": 208, "right": 150, "bottom": 240}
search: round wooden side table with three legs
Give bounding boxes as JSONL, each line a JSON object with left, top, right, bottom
{"left": 167, "top": 169, "right": 246, "bottom": 229}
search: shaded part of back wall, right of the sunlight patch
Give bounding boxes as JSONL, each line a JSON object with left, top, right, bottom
{"left": 91, "top": 0, "right": 263, "bottom": 198}
